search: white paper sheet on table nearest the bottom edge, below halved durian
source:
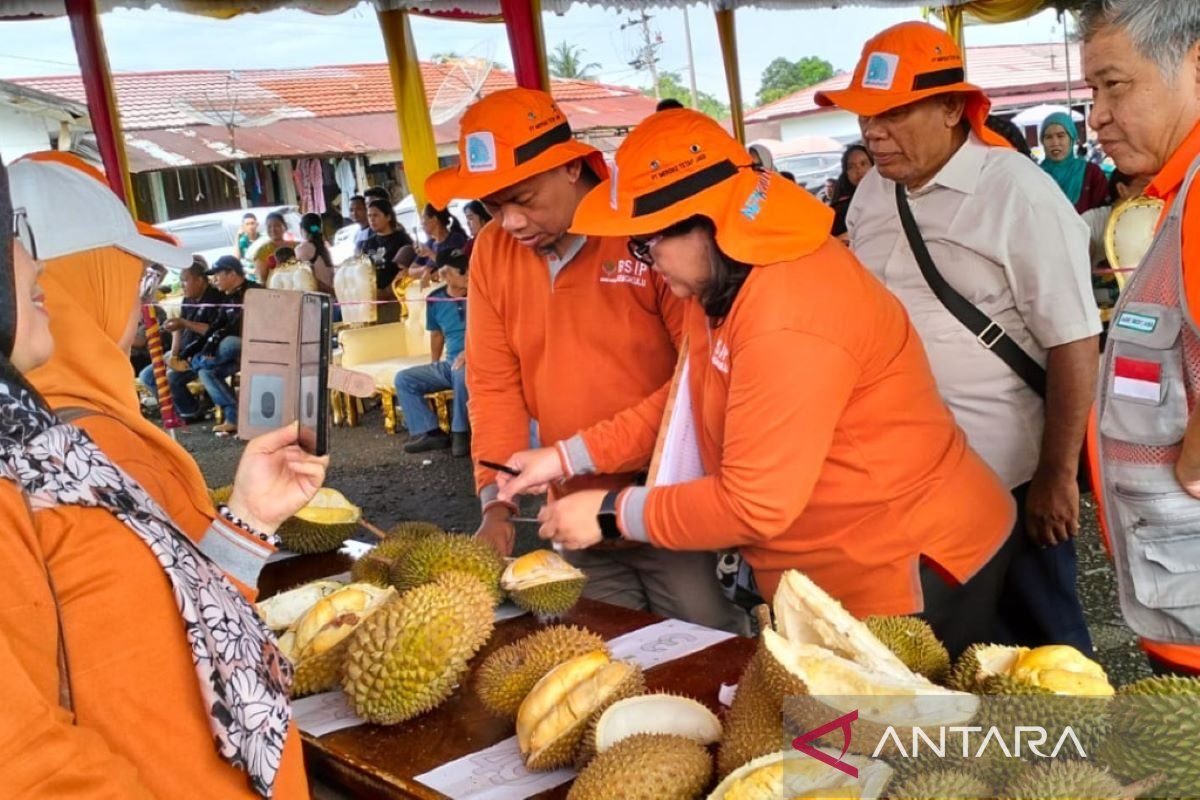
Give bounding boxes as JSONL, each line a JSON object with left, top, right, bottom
{"left": 416, "top": 736, "right": 576, "bottom": 800}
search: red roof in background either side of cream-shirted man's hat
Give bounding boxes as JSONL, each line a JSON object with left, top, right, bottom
{"left": 746, "top": 43, "right": 1085, "bottom": 122}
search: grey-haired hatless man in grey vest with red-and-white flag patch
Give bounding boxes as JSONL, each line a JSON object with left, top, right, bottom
{"left": 1081, "top": 0, "right": 1200, "bottom": 674}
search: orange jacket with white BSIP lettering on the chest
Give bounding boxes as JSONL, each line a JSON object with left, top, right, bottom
{"left": 467, "top": 224, "right": 684, "bottom": 501}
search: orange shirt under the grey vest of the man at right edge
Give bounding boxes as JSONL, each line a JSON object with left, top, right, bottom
{"left": 1087, "top": 118, "right": 1200, "bottom": 674}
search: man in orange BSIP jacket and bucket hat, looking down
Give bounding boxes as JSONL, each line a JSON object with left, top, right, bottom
{"left": 425, "top": 89, "right": 746, "bottom": 632}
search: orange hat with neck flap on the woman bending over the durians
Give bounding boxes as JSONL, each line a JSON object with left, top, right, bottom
{"left": 571, "top": 109, "right": 833, "bottom": 264}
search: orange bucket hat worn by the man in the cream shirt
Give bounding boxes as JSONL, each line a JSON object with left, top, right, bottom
{"left": 814, "top": 22, "right": 1012, "bottom": 148}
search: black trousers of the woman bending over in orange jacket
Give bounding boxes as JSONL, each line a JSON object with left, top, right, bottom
{"left": 917, "top": 522, "right": 1015, "bottom": 658}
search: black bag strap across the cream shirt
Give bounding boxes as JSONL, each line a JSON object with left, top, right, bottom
{"left": 896, "top": 184, "right": 1046, "bottom": 399}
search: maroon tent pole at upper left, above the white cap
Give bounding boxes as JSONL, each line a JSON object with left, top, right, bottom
{"left": 66, "top": 0, "right": 137, "bottom": 217}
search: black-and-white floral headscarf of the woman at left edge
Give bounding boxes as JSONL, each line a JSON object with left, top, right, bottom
{"left": 0, "top": 159, "right": 292, "bottom": 798}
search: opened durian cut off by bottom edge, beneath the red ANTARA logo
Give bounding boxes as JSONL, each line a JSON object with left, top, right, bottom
{"left": 708, "top": 747, "right": 892, "bottom": 800}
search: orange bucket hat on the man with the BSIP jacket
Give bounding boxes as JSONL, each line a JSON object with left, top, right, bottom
{"left": 425, "top": 89, "right": 608, "bottom": 209}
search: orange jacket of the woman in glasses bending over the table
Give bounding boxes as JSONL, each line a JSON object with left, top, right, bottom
{"left": 583, "top": 240, "right": 1013, "bottom": 616}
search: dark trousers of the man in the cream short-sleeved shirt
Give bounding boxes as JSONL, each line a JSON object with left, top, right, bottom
{"left": 996, "top": 483, "right": 1092, "bottom": 656}
